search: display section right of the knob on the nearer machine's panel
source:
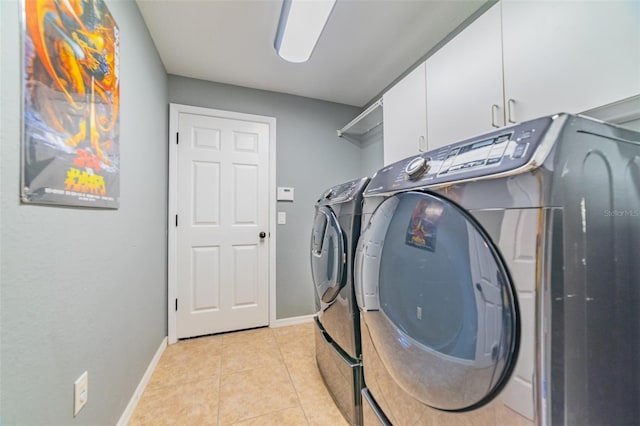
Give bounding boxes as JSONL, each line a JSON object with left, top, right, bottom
{"left": 438, "top": 133, "right": 512, "bottom": 176}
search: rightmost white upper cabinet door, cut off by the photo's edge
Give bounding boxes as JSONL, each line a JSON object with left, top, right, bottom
{"left": 502, "top": 0, "right": 640, "bottom": 122}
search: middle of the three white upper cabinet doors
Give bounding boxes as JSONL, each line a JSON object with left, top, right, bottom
{"left": 426, "top": 3, "right": 504, "bottom": 149}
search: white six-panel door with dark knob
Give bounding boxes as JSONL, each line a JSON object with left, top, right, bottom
{"left": 175, "top": 108, "right": 270, "bottom": 338}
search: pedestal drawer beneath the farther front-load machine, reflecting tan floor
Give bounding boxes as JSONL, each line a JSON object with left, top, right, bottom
{"left": 314, "top": 317, "right": 362, "bottom": 425}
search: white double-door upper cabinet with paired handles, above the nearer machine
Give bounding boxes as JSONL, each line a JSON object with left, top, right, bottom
{"left": 426, "top": 0, "right": 640, "bottom": 149}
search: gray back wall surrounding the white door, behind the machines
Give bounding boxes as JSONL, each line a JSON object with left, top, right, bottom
{"left": 169, "top": 75, "right": 361, "bottom": 319}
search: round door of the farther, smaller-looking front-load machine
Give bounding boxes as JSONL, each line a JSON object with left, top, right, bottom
{"left": 311, "top": 207, "right": 347, "bottom": 310}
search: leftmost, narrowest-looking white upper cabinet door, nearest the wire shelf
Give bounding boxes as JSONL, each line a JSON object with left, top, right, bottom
{"left": 382, "top": 63, "right": 427, "bottom": 164}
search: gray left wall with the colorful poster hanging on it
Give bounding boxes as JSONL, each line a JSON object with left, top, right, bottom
{"left": 0, "top": 0, "right": 168, "bottom": 425}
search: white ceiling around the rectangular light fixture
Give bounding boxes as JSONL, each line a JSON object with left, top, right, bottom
{"left": 136, "top": 0, "right": 487, "bottom": 107}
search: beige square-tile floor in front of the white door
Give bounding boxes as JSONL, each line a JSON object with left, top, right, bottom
{"left": 129, "top": 323, "right": 348, "bottom": 426}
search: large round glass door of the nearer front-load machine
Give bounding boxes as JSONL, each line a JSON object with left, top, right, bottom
{"left": 355, "top": 192, "right": 519, "bottom": 411}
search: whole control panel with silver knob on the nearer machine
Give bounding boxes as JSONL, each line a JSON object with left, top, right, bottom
{"left": 364, "top": 117, "right": 553, "bottom": 195}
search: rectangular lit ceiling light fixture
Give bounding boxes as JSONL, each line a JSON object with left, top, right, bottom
{"left": 274, "top": 0, "right": 336, "bottom": 63}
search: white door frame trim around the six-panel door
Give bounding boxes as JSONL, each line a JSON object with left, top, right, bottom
{"left": 167, "top": 103, "right": 276, "bottom": 344}
